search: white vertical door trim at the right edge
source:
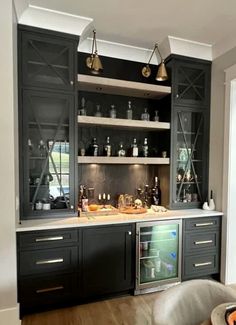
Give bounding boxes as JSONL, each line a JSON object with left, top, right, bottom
{"left": 221, "top": 65, "right": 236, "bottom": 284}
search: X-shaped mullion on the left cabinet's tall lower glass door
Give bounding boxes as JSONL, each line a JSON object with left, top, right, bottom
{"left": 29, "top": 97, "right": 68, "bottom": 208}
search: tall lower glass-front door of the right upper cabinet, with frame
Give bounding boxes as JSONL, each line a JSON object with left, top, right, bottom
{"left": 172, "top": 109, "right": 208, "bottom": 208}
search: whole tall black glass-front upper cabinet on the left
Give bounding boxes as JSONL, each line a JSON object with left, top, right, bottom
{"left": 18, "top": 25, "right": 78, "bottom": 219}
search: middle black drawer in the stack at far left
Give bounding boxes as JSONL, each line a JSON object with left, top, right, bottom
{"left": 19, "top": 247, "right": 78, "bottom": 275}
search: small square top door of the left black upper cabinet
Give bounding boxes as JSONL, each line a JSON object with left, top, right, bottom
{"left": 19, "top": 24, "right": 77, "bottom": 91}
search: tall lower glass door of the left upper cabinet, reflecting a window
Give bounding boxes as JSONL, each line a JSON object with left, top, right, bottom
{"left": 21, "top": 91, "right": 75, "bottom": 218}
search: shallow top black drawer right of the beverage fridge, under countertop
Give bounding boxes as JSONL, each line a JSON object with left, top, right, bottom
{"left": 184, "top": 217, "right": 220, "bottom": 231}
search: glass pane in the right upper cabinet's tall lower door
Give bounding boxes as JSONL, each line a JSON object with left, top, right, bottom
{"left": 175, "top": 111, "right": 204, "bottom": 203}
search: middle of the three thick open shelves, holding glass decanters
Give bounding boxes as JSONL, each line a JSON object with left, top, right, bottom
{"left": 77, "top": 115, "right": 170, "bottom": 131}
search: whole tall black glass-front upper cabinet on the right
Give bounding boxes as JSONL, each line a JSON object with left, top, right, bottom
{"left": 167, "top": 55, "right": 211, "bottom": 209}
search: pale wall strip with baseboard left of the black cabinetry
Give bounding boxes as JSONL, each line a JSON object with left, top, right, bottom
{"left": 0, "top": 0, "right": 19, "bottom": 325}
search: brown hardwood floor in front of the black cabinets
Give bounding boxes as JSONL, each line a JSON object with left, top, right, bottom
{"left": 22, "top": 292, "right": 159, "bottom": 325}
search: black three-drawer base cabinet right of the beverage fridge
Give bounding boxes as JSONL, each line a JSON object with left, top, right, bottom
{"left": 182, "top": 217, "right": 221, "bottom": 280}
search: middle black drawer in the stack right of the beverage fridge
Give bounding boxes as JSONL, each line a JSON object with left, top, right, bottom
{"left": 184, "top": 231, "right": 219, "bottom": 254}
